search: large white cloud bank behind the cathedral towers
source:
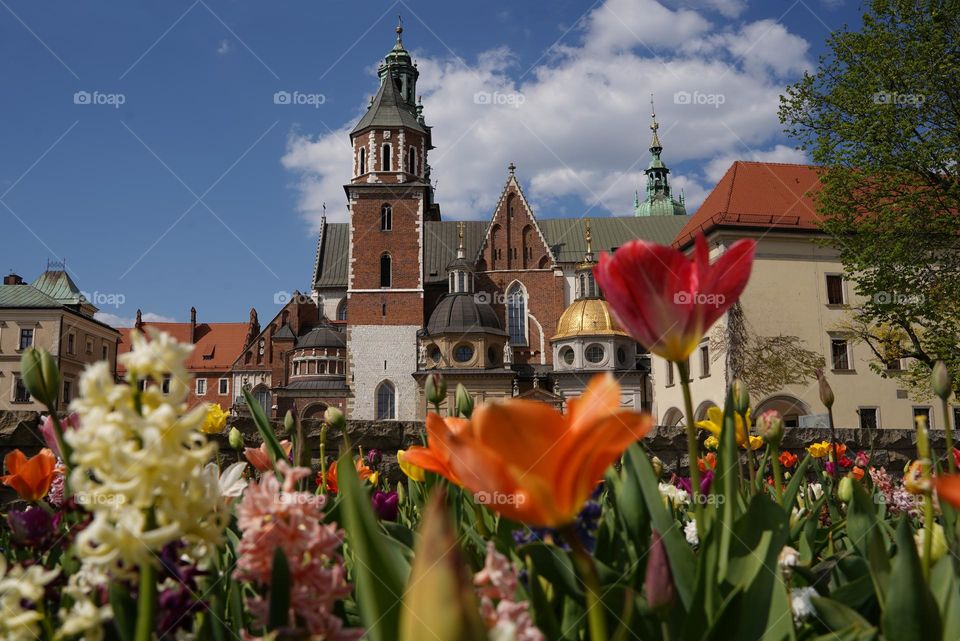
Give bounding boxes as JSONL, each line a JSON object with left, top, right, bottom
{"left": 282, "top": 0, "right": 809, "bottom": 227}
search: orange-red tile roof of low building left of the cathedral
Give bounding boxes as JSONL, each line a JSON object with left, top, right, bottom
{"left": 117, "top": 323, "right": 249, "bottom": 374}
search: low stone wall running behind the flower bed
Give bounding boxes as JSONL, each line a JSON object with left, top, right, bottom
{"left": 0, "top": 411, "right": 945, "bottom": 490}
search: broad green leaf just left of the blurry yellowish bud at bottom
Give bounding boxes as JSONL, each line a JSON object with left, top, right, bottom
{"left": 337, "top": 447, "right": 410, "bottom": 641}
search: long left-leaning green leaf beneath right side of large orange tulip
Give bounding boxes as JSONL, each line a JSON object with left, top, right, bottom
{"left": 624, "top": 443, "right": 697, "bottom": 610}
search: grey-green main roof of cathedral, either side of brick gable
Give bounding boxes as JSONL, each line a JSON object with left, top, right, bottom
{"left": 315, "top": 216, "right": 690, "bottom": 287}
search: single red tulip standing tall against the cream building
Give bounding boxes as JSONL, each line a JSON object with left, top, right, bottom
{"left": 594, "top": 235, "right": 756, "bottom": 363}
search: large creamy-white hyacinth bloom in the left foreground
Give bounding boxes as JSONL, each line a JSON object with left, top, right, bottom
{"left": 65, "top": 332, "right": 228, "bottom": 572}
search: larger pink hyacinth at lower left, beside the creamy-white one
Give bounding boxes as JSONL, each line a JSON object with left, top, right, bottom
{"left": 234, "top": 460, "right": 363, "bottom": 641}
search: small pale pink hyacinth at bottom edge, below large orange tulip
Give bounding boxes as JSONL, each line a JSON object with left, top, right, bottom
{"left": 473, "top": 542, "right": 544, "bottom": 641}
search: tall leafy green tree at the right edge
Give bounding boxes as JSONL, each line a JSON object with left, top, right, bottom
{"left": 780, "top": 0, "right": 960, "bottom": 395}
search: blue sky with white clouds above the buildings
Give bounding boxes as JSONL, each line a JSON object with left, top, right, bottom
{"left": 0, "top": 0, "right": 861, "bottom": 326}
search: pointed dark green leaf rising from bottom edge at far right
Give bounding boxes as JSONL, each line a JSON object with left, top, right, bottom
{"left": 881, "top": 517, "right": 941, "bottom": 641}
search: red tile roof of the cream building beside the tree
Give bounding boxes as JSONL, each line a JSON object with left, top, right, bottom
{"left": 673, "top": 160, "right": 820, "bottom": 248}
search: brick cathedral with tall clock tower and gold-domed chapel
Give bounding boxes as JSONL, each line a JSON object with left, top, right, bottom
{"left": 231, "top": 26, "right": 689, "bottom": 420}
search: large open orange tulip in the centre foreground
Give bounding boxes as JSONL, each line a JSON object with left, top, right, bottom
{"left": 405, "top": 374, "right": 653, "bottom": 527}
